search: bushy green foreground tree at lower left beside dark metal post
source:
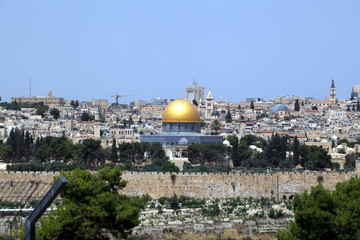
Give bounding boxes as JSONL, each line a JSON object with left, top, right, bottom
{"left": 37, "top": 167, "right": 146, "bottom": 240}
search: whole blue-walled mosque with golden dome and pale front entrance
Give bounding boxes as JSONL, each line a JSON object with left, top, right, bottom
{"left": 140, "top": 98, "right": 223, "bottom": 159}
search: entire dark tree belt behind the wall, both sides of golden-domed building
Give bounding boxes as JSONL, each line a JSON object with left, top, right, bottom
{"left": 0, "top": 129, "right": 358, "bottom": 172}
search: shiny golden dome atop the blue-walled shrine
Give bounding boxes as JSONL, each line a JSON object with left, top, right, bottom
{"left": 163, "top": 98, "right": 200, "bottom": 122}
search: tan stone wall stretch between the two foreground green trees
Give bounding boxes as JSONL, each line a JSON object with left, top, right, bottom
{"left": 123, "top": 172, "right": 357, "bottom": 199}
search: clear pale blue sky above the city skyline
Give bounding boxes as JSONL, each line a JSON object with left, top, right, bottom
{"left": 0, "top": 0, "right": 360, "bottom": 101}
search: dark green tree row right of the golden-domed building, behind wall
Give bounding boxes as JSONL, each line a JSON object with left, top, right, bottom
{"left": 188, "top": 134, "right": 357, "bottom": 170}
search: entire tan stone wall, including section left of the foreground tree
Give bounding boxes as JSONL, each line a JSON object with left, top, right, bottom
{"left": 0, "top": 161, "right": 360, "bottom": 200}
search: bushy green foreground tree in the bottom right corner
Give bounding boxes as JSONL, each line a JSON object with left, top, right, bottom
{"left": 276, "top": 178, "right": 360, "bottom": 240}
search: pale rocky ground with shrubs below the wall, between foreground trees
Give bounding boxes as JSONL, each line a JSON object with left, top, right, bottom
{"left": 133, "top": 197, "right": 293, "bottom": 240}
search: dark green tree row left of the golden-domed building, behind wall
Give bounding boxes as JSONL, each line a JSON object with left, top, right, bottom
{"left": 0, "top": 129, "right": 179, "bottom": 171}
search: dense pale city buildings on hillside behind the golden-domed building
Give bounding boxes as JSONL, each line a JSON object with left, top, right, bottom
{"left": 0, "top": 80, "right": 360, "bottom": 169}
